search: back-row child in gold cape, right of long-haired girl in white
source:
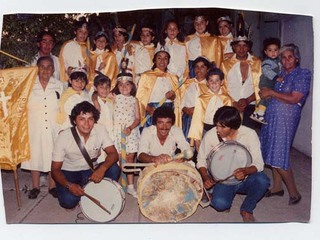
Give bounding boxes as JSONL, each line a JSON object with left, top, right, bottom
{"left": 185, "top": 15, "right": 223, "bottom": 78}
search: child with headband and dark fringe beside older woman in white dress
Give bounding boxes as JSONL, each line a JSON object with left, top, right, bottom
{"left": 57, "top": 68, "right": 90, "bottom": 131}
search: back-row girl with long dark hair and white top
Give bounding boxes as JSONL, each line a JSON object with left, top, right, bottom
{"left": 156, "top": 20, "right": 188, "bottom": 83}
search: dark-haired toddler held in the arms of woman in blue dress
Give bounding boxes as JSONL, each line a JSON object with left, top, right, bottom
{"left": 250, "top": 38, "right": 282, "bottom": 124}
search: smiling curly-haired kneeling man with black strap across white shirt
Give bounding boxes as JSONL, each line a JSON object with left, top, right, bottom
{"left": 51, "top": 101, "right": 120, "bottom": 209}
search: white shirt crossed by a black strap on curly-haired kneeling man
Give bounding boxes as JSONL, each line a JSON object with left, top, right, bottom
{"left": 52, "top": 124, "right": 113, "bottom": 171}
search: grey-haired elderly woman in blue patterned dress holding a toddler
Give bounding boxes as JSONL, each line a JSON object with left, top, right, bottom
{"left": 259, "top": 44, "right": 311, "bottom": 205}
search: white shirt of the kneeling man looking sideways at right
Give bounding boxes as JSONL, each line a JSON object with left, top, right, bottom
{"left": 197, "top": 125, "right": 264, "bottom": 172}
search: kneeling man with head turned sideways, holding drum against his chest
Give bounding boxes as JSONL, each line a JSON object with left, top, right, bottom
{"left": 197, "top": 106, "right": 270, "bottom": 222}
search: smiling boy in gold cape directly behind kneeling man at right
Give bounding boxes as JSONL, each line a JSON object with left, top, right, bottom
{"left": 188, "top": 68, "right": 232, "bottom": 151}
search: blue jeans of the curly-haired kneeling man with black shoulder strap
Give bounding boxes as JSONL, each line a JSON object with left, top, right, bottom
{"left": 57, "top": 163, "right": 121, "bottom": 209}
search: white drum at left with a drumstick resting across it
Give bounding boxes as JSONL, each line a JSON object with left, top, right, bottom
{"left": 80, "top": 178, "right": 125, "bottom": 222}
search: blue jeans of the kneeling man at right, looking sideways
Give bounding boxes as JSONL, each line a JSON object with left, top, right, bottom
{"left": 211, "top": 172, "right": 270, "bottom": 213}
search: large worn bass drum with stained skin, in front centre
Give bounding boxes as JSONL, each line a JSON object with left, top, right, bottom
{"left": 137, "top": 162, "right": 203, "bottom": 222}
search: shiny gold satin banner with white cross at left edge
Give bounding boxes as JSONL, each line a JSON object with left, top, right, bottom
{"left": 0, "top": 67, "right": 38, "bottom": 170}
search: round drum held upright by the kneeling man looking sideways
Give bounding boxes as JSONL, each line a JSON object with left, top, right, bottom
{"left": 207, "top": 141, "right": 252, "bottom": 185}
